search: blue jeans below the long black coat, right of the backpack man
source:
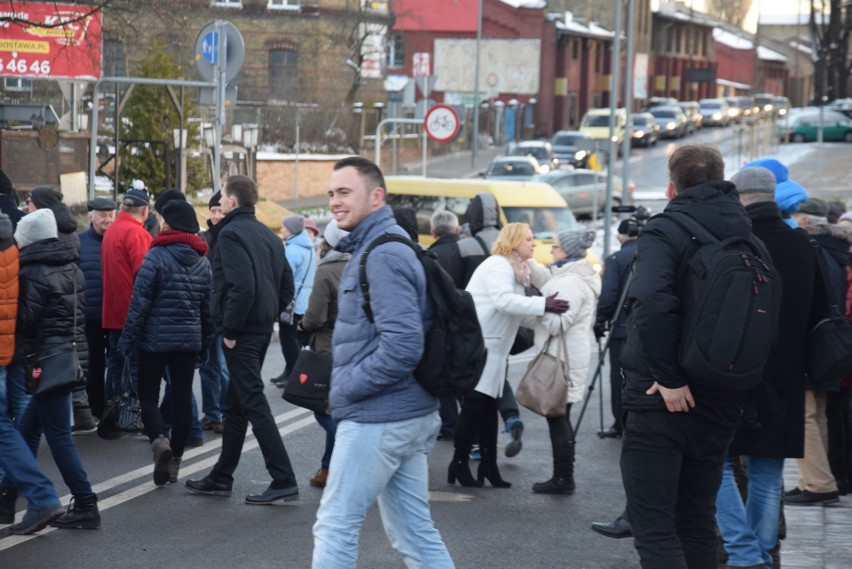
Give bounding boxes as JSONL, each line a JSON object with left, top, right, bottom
{"left": 716, "top": 456, "right": 784, "bottom": 568}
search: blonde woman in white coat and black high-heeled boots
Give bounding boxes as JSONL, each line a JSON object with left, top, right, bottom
{"left": 447, "top": 223, "right": 568, "bottom": 488}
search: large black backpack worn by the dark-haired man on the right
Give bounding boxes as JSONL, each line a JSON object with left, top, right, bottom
{"left": 660, "top": 212, "right": 781, "bottom": 391}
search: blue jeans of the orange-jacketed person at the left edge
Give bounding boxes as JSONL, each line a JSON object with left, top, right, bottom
{"left": 0, "top": 366, "right": 59, "bottom": 510}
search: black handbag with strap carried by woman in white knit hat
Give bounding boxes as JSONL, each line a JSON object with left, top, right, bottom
{"left": 26, "top": 269, "right": 86, "bottom": 397}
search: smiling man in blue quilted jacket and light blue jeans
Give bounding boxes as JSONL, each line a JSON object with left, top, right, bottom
{"left": 313, "top": 156, "right": 453, "bottom": 569}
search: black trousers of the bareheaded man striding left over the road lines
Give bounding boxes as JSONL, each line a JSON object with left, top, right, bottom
{"left": 210, "top": 334, "right": 296, "bottom": 488}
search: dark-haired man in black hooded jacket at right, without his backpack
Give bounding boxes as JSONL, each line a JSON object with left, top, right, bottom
{"left": 621, "top": 144, "right": 751, "bottom": 569}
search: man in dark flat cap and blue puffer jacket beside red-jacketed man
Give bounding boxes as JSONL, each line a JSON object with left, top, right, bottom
{"left": 79, "top": 198, "right": 117, "bottom": 417}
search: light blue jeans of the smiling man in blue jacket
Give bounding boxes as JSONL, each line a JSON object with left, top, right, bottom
{"left": 313, "top": 411, "right": 454, "bottom": 569}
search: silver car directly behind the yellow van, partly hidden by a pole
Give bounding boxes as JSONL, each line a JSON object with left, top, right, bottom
{"left": 533, "top": 169, "right": 630, "bottom": 216}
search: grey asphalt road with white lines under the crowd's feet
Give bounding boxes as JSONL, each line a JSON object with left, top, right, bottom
{"left": 0, "top": 344, "right": 638, "bottom": 569}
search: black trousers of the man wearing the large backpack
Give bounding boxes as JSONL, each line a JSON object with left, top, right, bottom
{"left": 621, "top": 408, "right": 742, "bottom": 569}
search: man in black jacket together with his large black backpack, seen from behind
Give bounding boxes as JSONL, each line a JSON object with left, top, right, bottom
{"left": 621, "top": 144, "right": 780, "bottom": 569}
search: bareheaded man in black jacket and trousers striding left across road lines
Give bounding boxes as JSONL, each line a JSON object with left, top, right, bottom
{"left": 186, "top": 176, "right": 299, "bottom": 504}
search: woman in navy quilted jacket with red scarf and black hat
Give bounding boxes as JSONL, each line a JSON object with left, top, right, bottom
{"left": 118, "top": 200, "right": 213, "bottom": 486}
